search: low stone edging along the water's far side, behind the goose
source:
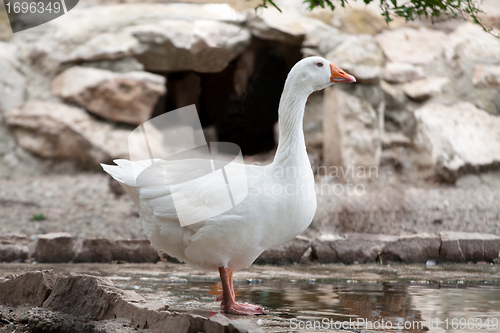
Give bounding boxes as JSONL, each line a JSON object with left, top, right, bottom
{"left": 0, "top": 231, "right": 500, "bottom": 264}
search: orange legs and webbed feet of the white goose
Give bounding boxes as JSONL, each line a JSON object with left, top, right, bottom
{"left": 217, "top": 267, "right": 269, "bottom": 316}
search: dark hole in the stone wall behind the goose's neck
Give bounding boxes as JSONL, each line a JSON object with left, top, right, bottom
{"left": 146, "top": 38, "right": 302, "bottom": 155}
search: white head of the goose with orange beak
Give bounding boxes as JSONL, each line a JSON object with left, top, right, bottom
{"left": 289, "top": 57, "right": 356, "bottom": 93}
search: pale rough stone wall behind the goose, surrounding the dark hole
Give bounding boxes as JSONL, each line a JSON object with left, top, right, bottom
{"left": 0, "top": 1, "right": 500, "bottom": 182}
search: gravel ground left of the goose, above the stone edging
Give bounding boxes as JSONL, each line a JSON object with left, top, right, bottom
{"left": 0, "top": 174, "right": 146, "bottom": 239}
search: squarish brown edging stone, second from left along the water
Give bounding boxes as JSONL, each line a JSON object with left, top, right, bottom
{"left": 33, "top": 232, "right": 75, "bottom": 263}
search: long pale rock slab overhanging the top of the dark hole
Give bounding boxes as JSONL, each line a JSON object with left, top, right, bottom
{"left": 13, "top": 3, "right": 251, "bottom": 73}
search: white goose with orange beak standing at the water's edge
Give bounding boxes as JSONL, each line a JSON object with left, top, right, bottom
{"left": 102, "top": 57, "right": 356, "bottom": 315}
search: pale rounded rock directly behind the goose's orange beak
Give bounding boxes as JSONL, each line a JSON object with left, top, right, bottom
{"left": 326, "top": 35, "right": 384, "bottom": 83}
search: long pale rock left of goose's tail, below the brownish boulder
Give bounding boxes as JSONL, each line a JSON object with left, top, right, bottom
{"left": 4, "top": 101, "right": 130, "bottom": 169}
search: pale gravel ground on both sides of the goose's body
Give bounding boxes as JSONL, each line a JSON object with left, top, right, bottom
{"left": 0, "top": 173, "right": 500, "bottom": 244}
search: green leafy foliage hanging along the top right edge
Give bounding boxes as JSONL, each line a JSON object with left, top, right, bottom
{"left": 258, "top": 0, "right": 498, "bottom": 37}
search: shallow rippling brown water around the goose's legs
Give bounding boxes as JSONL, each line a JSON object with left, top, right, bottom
{"left": 0, "top": 263, "right": 500, "bottom": 333}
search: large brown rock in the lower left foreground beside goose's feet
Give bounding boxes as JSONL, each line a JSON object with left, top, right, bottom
{"left": 0, "top": 270, "right": 263, "bottom": 333}
